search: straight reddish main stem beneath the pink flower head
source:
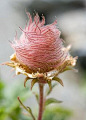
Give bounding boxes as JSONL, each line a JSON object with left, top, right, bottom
{"left": 38, "top": 83, "right": 44, "bottom": 120}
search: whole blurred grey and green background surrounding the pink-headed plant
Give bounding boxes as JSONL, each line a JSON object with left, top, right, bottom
{"left": 0, "top": 0, "right": 86, "bottom": 120}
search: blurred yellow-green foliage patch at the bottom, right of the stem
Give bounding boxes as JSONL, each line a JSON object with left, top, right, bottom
{"left": 43, "top": 106, "right": 73, "bottom": 120}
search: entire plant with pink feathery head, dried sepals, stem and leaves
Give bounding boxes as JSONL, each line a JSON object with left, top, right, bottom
{"left": 4, "top": 12, "right": 77, "bottom": 120}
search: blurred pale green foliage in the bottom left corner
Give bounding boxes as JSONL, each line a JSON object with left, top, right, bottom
{"left": 0, "top": 80, "right": 32, "bottom": 120}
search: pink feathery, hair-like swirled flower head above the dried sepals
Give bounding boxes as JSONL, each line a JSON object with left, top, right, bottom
{"left": 12, "top": 13, "right": 76, "bottom": 73}
